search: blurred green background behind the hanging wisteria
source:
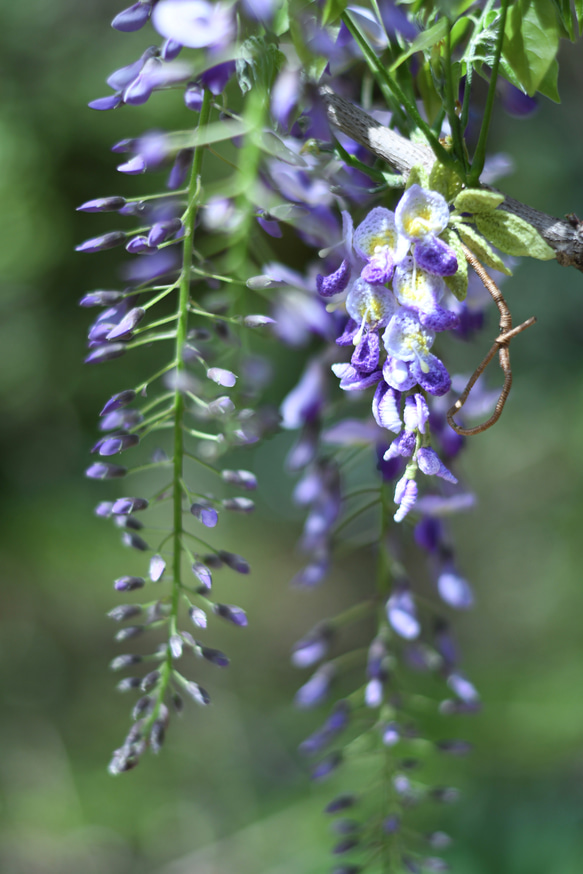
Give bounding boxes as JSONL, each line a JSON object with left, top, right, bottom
{"left": 0, "top": 0, "right": 583, "bottom": 874}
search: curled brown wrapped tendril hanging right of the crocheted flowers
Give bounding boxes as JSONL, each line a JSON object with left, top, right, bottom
{"left": 447, "top": 243, "right": 536, "bottom": 437}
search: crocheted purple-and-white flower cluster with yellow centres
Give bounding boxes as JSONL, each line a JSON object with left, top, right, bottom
{"left": 317, "top": 183, "right": 458, "bottom": 521}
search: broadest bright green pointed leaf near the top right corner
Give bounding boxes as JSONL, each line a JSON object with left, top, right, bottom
{"left": 503, "top": 0, "right": 559, "bottom": 97}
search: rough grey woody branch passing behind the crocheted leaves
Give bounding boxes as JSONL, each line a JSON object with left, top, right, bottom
{"left": 320, "top": 85, "right": 583, "bottom": 272}
